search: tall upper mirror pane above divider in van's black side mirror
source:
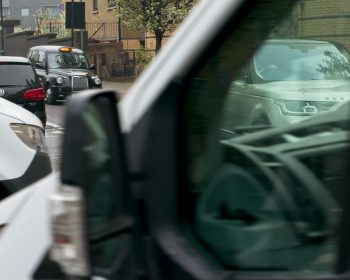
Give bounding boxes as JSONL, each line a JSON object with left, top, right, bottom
{"left": 82, "top": 100, "right": 116, "bottom": 232}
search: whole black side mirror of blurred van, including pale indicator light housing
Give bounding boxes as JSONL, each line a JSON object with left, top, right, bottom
{"left": 51, "top": 90, "right": 131, "bottom": 277}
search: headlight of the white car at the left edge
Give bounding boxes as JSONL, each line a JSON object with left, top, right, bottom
{"left": 10, "top": 123, "right": 47, "bottom": 152}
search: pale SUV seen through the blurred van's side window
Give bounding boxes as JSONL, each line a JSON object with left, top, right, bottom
{"left": 225, "top": 39, "right": 350, "bottom": 129}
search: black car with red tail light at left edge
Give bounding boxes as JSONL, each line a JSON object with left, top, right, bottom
{"left": 0, "top": 56, "right": 46, "bottom": 127}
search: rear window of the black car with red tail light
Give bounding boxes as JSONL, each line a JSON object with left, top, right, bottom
{"left": 0, "top": 63, "right": 36, "bottom": 86}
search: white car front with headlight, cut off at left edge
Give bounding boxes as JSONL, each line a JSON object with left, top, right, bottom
{"left": 0, "top": 97, "right": 52, "bottom": 199}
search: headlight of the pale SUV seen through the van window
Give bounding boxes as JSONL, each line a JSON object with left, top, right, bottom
{"left": 276, "top": 100, "right": 320, "bottom": 116}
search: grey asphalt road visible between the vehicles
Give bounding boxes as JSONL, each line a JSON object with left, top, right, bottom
{"left": 45, "top": 82, "right": 131, "bottom": 170}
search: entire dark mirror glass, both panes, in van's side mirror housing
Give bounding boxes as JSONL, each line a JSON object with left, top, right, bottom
{"left": 81, "top": 97, "right": 126, "bottom": 268}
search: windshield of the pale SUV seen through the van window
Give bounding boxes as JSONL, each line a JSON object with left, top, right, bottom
{"left": 254, "top": 41, "right": 350, "bottom": 81}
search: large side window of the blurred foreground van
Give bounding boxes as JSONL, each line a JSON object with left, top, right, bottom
{"left": 180, "top": 0, "right": 350, "bottom": 277}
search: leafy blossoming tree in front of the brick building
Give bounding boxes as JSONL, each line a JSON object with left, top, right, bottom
{"left": 116, "top": 0, "right": 194, "bottom": 52}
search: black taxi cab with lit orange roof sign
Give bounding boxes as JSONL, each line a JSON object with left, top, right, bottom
{"left": 27, "top": 46, "right": 102, "bottom": 104}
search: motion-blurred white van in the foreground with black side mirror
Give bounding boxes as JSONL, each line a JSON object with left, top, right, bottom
{"left": 0, "top": 0, "right": 350, "bottom": 280}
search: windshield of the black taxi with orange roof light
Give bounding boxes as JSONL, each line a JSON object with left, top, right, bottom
{"left": 48, "top": 52, "right": 89, "bottom": 70}
